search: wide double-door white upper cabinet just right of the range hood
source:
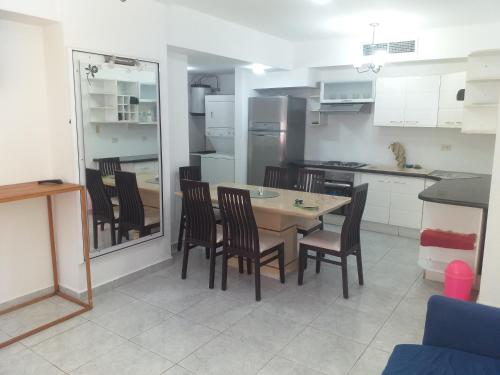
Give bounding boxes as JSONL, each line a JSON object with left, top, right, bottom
{"left": 374, "top": 76, "right": 441, "bottom": 127}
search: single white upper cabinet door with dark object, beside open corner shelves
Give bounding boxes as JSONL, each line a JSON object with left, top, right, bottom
{"left": 438, "top": 72, "right": 466, "bottom": 128}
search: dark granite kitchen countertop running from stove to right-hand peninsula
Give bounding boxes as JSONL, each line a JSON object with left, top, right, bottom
{"left": 291, "top": 160, "right": 491, "bottom": 209}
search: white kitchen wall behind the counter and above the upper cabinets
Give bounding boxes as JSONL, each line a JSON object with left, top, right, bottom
{"left": 258, "top": 61, "right": 495, "bottom": 173}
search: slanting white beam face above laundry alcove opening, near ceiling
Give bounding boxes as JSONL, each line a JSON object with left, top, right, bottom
{"left": 167, "top": 5, "right": 293, "bottom": 69}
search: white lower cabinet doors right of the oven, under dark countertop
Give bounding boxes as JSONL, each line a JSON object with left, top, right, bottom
{"left": 361, "top": 173, "right": 425, "bottom": 229}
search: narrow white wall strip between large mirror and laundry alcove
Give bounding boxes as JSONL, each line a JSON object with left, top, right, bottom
{"left": 168, "top": 52, "right": 189, "bottom": 248}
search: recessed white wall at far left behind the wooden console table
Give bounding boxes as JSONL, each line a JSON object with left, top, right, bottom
{"left": 0, "top": 19, "right": 52, "bottom": 303}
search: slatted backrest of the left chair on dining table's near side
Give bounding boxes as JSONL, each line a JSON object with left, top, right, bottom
{"left": 181, "top": 180, "right": 217, "bottom": 246}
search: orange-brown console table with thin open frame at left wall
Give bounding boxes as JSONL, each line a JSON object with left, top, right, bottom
{"left": 0, "top": 182, "right": 92, "bottom": 348}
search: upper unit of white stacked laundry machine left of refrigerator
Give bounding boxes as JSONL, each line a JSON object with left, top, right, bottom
{"left": 205, "top": 95, "right": 234, "bottom": 128}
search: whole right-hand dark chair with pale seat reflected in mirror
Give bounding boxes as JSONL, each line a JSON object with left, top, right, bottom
{"left": 115, "top": 171, "right": 160, "bottom": 243}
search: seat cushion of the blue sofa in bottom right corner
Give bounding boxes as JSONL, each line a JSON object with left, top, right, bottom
{"left": 382, "top": 344, "right": 500, "bottom": 375}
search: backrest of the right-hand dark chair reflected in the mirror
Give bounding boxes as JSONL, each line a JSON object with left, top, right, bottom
{"left": 115, "top": 171, "right": 144, "bottom": 228}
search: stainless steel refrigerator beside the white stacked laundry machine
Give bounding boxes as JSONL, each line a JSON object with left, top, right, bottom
{"left": 247, "top": 96, "right": 306, "bottom": 186}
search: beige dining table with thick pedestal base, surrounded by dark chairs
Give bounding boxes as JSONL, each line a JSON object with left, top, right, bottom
{"left": 175, "top": 183, "right": 351, "bottom": 279}
